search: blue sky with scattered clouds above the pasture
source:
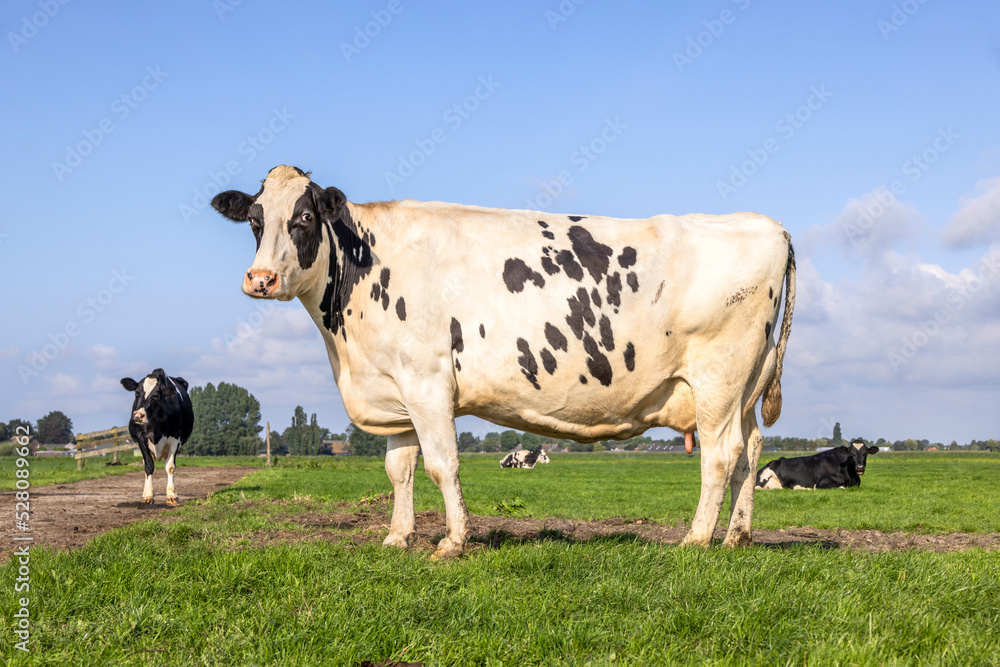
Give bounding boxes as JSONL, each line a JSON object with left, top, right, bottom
{"left": 0, "top": 0, "right": 1000, "bottom": 443}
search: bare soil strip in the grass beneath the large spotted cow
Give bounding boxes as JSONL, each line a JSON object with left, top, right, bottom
{"left": 238, "top": 501, "right": 1000, "bottom": 553}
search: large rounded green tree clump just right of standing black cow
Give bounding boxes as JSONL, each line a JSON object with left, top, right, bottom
{"left": 184, "top": 382, "right": 263, "bottom": 456}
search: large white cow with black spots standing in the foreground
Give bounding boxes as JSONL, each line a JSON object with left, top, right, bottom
{"left": 212, "top": 165, "right": 795, "bottom": 558}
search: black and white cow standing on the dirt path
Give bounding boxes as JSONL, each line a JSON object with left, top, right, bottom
{"left": 122, "top": 368, "right": 194, "bottom": 505}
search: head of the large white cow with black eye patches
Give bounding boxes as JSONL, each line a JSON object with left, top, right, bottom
{"left": 212, "top": 165, "right": 350, "bottom": 301}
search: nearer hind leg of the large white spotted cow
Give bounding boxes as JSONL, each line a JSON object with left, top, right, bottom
{"left": 682, "top": 409, "right": 743, "bottom": 546}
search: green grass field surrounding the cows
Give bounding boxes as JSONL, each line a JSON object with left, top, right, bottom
{"left": 0, "top": 453, "right": 1000, "bottom": 665}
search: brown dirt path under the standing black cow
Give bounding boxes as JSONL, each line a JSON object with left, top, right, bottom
{"left": 0, "top": 466, "right": 258, "bottom": 558}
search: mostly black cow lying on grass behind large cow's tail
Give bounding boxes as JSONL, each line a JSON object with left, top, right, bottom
{"left": 757, "top": 439, "right": 878, "bottom": 489}
